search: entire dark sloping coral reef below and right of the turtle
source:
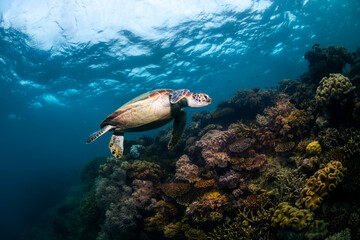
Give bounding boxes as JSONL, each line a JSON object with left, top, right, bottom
{"left": 37, "top": 45, "right": 360, "bottom": 240}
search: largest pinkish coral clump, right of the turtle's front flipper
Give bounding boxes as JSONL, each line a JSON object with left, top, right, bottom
{"left": 195, "top": 130, "right": 235, "bottom": 167}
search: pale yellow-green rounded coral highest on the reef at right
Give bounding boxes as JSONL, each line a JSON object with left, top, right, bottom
{"left": 315, "top": 73, "right": 353, "bottom": 106}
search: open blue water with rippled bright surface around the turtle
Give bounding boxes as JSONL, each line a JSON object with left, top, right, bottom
{"left": 0, "top": 0, "right": 360, "bottom": 239}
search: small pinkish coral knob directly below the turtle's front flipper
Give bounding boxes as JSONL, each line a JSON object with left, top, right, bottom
{"left": 175, "top": 154, "right": 200, "bottom": 183}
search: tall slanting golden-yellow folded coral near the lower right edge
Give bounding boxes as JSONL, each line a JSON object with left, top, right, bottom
{"left": 296, "top": 161, "right": 346, "bottom": 210}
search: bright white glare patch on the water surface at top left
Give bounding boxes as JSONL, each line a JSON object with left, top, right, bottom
{"left": 0, "top": 0, "right": 272, "bottom": 50}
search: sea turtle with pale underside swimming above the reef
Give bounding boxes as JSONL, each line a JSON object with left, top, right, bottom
{"left": 86, "top": 89, "right": 211, "bottom": 158}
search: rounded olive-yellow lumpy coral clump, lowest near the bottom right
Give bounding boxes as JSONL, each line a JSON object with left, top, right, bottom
{"left": 271, "top": 202, "right": 313, "bottom": 230}
